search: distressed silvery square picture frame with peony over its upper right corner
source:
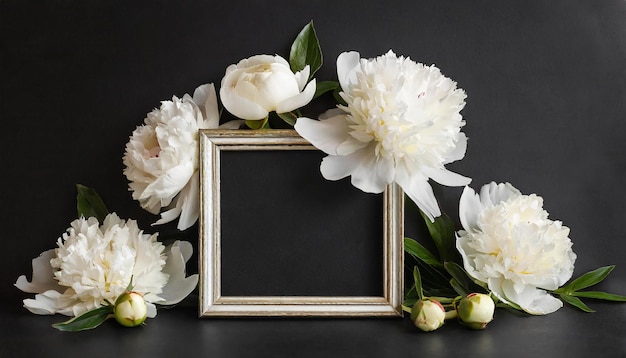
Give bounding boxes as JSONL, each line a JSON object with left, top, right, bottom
{"left": 199, "top": 129, "right": 404, "bottom": 317}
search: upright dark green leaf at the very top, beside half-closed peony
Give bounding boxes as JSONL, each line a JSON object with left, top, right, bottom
{"left": 289, "top": 21, "right": 323, "bottom": 79}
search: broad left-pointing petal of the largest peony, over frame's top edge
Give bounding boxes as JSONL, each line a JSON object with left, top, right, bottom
{"left": 294, "top": 115, "right": 352, "bottom": 155}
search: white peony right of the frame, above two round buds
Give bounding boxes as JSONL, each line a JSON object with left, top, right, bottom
{"left": 457, "top": 182, "right": 576, "bottom": 314}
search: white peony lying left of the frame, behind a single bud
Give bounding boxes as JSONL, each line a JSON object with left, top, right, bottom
{"left": 15, "top": 213, "right": 198, "bottom": 317}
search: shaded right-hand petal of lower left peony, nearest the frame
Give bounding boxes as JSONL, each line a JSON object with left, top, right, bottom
{"left": 159, "top": 241, "right": 198, "bottom": 305}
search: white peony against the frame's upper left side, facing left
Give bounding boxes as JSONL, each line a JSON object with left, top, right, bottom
{"left": 123, "top": 84, "right": 241, "bottom": 230}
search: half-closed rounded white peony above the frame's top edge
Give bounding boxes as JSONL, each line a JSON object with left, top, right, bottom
{"left": 220, "top": 55, "right": 316, "bottom": 120}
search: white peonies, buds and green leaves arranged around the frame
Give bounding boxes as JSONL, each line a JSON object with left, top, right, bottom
{"left": 15, "top": 22, "right": 626, "bottom": 331}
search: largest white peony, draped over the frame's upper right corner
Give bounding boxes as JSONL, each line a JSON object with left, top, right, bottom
{"left": 295, "top": 51, "right": 470, "bottom": 220}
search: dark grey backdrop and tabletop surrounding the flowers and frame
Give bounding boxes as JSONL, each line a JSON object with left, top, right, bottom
{"left": 0, "top": 0, "right": 626, "bottom": 358}
